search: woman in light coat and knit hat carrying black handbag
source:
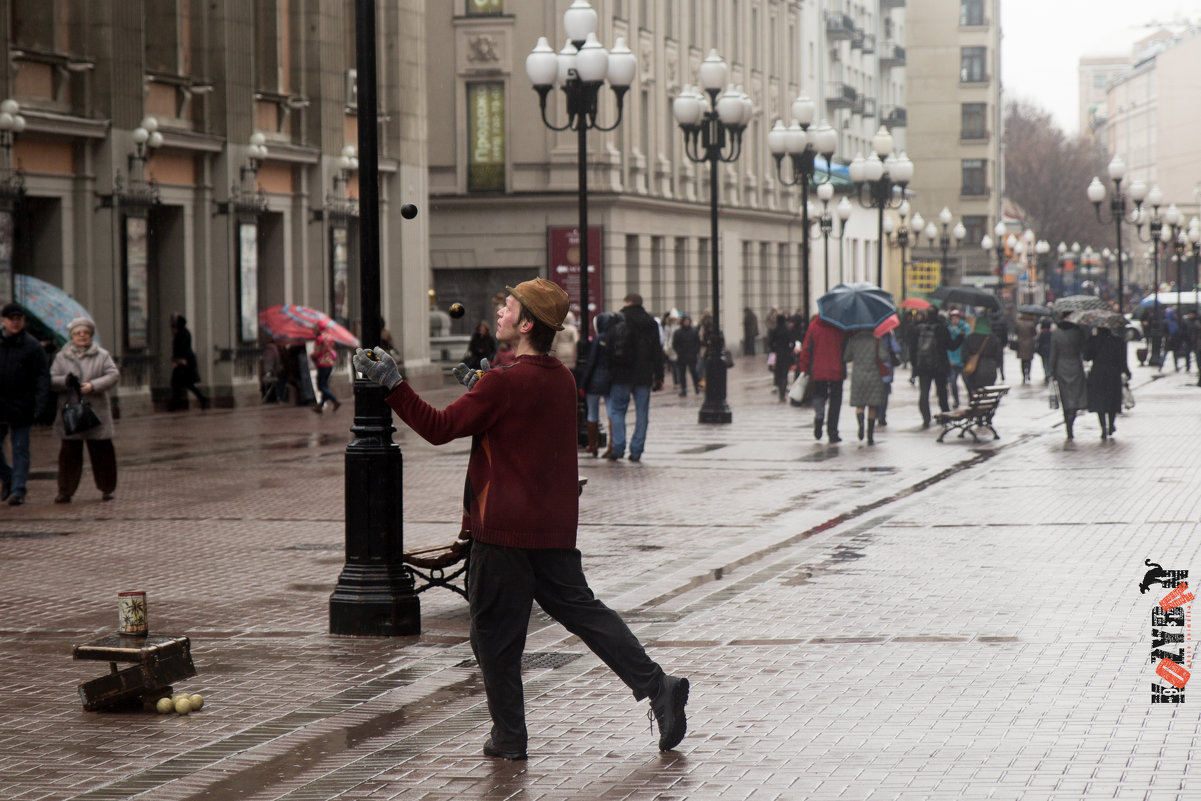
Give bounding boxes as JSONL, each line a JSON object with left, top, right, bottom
{"left": 50, "top": 317, "right": 121, "bottom": 503}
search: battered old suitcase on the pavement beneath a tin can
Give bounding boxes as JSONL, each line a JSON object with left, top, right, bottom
{"left": 73, "top": 634, "right": 196, "bottom": 712}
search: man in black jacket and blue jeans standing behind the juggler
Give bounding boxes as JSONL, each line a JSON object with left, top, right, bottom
{"left": 605, "top": 292, "right": 663, "bottom": 461}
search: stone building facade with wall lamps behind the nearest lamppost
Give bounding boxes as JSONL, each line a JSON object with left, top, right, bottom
{"left": 0, "top": 0, "right": 429, "bottom": 407}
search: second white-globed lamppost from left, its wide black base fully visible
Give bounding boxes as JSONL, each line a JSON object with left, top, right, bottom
{"left": 671, "top": 49, "right": 744, "bottom": 423}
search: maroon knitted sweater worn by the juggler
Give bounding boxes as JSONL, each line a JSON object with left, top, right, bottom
{"left": 388, "top": 355, "right": 579, "bottom": 548}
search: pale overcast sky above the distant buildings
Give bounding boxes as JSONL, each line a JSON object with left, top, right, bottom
{"left": 1000, "top": 0, "right": 1201, "bottom": 133}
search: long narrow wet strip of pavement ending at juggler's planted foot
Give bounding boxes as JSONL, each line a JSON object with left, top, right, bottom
{"left": 179, "top": 673, "right": 484, "bottom": 801}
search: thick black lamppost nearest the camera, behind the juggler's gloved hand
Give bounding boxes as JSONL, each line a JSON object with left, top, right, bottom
{"left": 329, "top": 0, "right": 422, "bottom": 636}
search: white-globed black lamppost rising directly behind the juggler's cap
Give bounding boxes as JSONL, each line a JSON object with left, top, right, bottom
{"left": 526, "top": 0, "right": 638, "bottom": 350}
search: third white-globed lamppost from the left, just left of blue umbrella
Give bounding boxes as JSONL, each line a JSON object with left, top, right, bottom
{"left": 767, "top": 95, "right": 838, "bottom": 316}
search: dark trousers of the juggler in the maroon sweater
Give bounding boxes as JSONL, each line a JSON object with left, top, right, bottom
{"left": 467, "top": 542, "right": 663, "bottom": 751}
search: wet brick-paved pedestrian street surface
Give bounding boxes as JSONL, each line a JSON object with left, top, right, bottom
{"left": 0, "top": 354, "right": 1201, "bottom": 801}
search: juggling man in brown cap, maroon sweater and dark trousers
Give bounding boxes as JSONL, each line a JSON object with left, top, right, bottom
{"left": 354, "top": 279, "right": 688, "bottom": 759}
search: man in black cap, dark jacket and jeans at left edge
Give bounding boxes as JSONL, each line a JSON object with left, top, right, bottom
{"left": 0, "top": 303, "right": 50, "bottom": 506}
